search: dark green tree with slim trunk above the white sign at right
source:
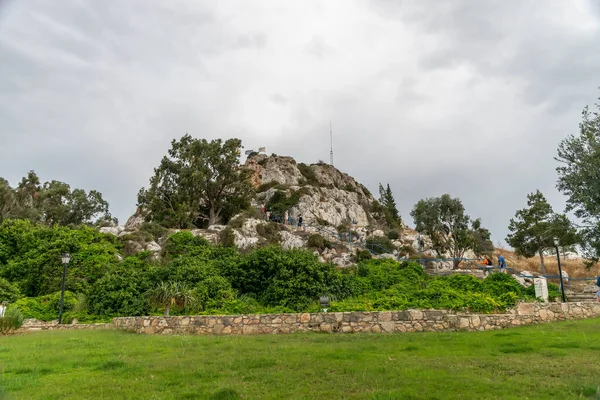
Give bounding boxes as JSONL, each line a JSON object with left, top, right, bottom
{"left": 506, "top": 190, "right": 577, "bottom": 273}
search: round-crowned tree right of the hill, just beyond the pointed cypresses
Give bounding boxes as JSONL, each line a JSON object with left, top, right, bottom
{"left": 410, "top": 194, "right": 491, "bottom": 268}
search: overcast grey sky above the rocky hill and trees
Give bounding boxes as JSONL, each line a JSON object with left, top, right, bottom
{"left": 0, "top": 0, "right": 600, "bottom": 243}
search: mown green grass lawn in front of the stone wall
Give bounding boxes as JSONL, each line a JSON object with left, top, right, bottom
{"left": 0, "top": 319, "right": 600, "bottom": 400}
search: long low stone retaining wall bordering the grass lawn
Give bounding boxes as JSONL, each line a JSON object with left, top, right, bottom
{"left": 113, "top": 302, "right": 600, "bottom": 335}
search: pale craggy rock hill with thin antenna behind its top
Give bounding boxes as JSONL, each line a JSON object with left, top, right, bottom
{"left": 101, "top": 154, "right": 428, "bottom": 266}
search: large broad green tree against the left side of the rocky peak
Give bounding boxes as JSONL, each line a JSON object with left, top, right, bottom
{"left": 138, "top": 135, "right": 252, "bottom": 228}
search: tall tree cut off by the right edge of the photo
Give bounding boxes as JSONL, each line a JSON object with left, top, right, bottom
{"left": 555, "top": 96, "right": 600, "bottom": 266}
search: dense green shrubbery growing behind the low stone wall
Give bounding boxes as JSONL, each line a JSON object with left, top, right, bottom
{"left": 0, "top": 220, "right": 548, "bottom": 321}
